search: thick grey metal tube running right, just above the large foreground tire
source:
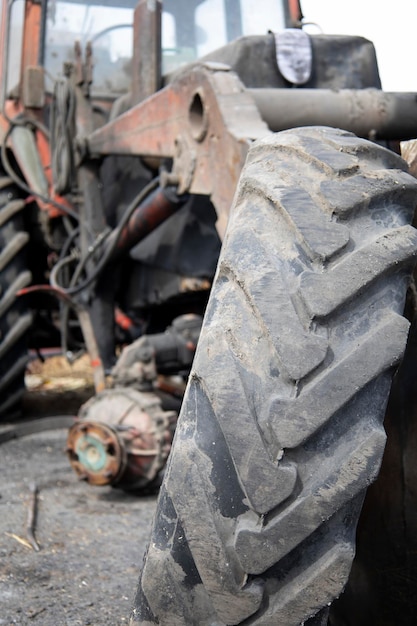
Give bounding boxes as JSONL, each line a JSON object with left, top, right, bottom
{"left": 248, "top": 89, "right": 417, "bottom": 140}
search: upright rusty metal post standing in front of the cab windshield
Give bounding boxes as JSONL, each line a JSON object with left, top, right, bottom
{"left": 132, "top": 0, "right": 162, "bottom": 104}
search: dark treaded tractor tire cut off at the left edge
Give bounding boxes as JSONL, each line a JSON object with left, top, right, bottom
{"left": 0, "top": 176, "right": 32, "bottom": 420}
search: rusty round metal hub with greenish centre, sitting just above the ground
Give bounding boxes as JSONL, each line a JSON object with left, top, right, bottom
{"left": 67, "top": 387, "right": 177, "bottom": 491}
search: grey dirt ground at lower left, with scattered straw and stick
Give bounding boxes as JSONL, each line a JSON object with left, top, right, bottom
{"left": 0, "top": 356, "right": 156, "bottom": 626}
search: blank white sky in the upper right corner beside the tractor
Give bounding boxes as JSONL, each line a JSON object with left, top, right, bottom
{"left": 301, "top": 0, "right": 417, "bottom": 92}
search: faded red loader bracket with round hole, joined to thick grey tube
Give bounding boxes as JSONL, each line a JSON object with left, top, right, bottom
{"left": 88, "top": 63, "right": 417, "bottom": 236}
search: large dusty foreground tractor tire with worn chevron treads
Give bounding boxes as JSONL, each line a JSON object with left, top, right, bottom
{"left": 131, "top": 127, "right": 417, "bottom": 626}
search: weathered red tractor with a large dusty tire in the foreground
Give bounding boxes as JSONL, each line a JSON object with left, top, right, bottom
{"left": 0, "top": 0, "right": 417, "bottom": 626}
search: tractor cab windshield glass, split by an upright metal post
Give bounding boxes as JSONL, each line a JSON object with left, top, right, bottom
{"left": 44, "top": 0, "right": 285, "bottom": 97}
